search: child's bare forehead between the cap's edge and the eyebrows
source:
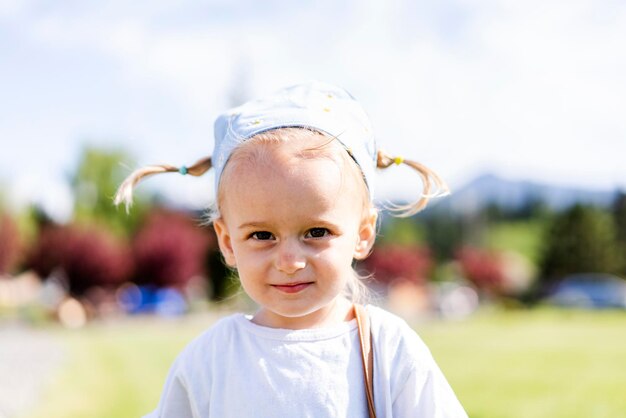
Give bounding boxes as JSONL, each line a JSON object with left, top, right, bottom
{"left": 218, "top": 131, "right": 369, "bottom": 219}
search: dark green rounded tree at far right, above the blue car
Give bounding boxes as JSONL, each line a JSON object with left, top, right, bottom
{"left": 541, "top": 205, "right": 621, "bottom": 281}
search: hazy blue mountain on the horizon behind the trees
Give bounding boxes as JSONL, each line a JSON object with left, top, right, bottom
{"left": 434, "top": 174, "right": 617, "bottom": 213}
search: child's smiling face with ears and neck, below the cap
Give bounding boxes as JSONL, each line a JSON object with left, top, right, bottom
{"left": 214, "top": 137, "right": 376, "bottom": 329}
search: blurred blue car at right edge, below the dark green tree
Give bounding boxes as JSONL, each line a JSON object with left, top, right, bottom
{"left": 548, "top": 273, "right": 626, "bottom": 309}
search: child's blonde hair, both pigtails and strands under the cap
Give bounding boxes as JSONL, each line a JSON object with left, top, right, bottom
{"left": 114, "top": 128, "right": 449, "bottom": 303}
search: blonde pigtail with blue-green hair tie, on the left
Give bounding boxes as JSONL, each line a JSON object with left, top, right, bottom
{"left": 113, "top": 157, "right": 213, "bottom": 212}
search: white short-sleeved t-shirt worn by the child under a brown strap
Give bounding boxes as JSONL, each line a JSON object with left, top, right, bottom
{"left": 147, "top": 305, "right": 467, "bottom": 418}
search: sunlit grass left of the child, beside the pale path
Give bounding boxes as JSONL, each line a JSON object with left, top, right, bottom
{"left": 27, "top": 317, "right": 217, "bottom": 418}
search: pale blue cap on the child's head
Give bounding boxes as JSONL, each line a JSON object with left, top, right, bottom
{"left": 212, "top": 81, "right": 376, "bottom": 198}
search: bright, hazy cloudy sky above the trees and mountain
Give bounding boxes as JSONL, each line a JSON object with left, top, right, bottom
{"left": 0, "top": 0, "right": 626, "bottom": 220}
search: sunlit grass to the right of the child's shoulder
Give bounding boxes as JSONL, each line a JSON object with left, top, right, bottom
{"left": 416, "top": 310, "right": 626, "bottom": 418}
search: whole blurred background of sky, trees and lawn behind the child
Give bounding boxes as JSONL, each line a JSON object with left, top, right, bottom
{"left": 0, "top": 0, "right": 626, "bottom": 418}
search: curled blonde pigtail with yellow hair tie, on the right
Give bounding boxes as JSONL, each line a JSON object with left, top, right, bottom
{"left": 376, "top": 150, "right": 450, "bottom": 218}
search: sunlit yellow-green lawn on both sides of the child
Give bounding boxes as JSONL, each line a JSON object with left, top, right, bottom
{"left": 24, "top": 309, "right": 626, "bottom": 418}
